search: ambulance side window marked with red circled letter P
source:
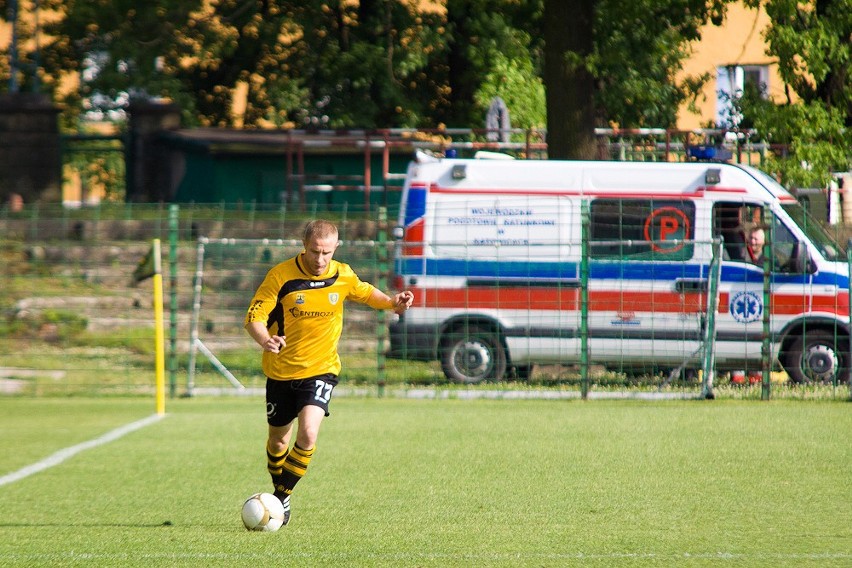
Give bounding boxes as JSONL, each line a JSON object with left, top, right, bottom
{"left": 590, "top": 199, "right": 695, "bottom": 261}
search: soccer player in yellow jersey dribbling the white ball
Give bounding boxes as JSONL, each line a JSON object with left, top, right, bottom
{"left": 245, "top": 219, "right": 414, "bottom": 525}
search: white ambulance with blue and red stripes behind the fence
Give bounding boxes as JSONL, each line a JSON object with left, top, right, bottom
{"left": 389, "top": 154, "right": 850, "bottom": 383}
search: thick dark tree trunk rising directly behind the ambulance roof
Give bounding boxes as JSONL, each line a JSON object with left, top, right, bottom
{"left": 544, "top": 0, "right": 597, "bottom": 160}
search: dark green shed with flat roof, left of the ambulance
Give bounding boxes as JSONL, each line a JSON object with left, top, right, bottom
{"left": 159, "top": 128, "right": 416, "bottom": 210}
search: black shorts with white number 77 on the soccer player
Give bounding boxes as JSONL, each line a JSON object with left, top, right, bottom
{"left": 266, "top": 373, "right": 337, "bottom": 426}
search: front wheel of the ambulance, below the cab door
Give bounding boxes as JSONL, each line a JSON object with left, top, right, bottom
{"left": 784, "top": 330, "right": 847, "bottom": 383}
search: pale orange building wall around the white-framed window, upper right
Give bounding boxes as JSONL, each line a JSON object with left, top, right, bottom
{"left": 677, "top": 2, "right": 786, "bottom": 130}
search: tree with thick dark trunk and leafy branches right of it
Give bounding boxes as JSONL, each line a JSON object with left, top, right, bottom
{"left": 543, "top": 0, "right": 729, "bottom": 158}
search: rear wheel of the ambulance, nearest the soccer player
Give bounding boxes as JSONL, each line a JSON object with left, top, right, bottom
{"left": 441, "top": 327, "right": 506, "bottom": 384}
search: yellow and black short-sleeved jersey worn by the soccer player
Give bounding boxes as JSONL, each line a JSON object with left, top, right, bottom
{"left": 245, "top": 256, "right": 375, "bottom": 380}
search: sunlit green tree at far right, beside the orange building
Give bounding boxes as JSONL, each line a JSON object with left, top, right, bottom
{"left": 736, "top": 0, "right": 852, "bottom": 187}
